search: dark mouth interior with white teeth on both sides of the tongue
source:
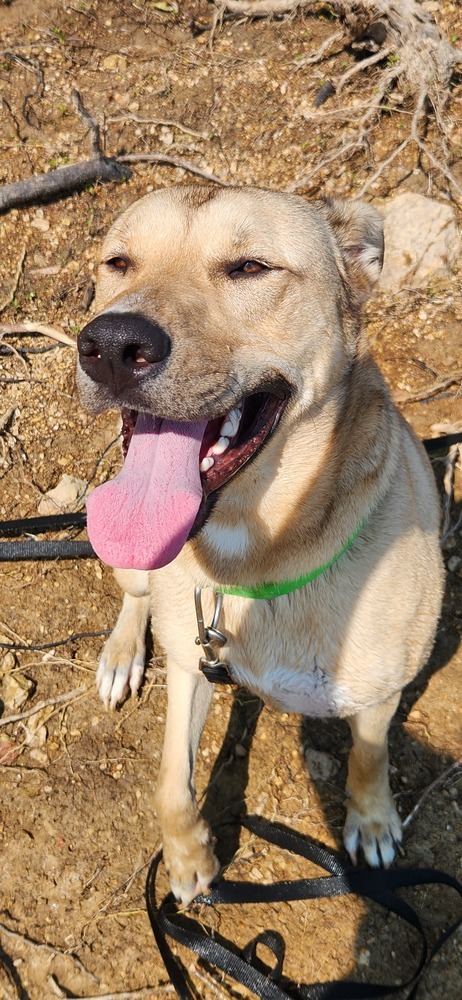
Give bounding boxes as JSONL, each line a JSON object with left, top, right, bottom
{"left": 122, "top": 386, "right": 289, "bottom": 497}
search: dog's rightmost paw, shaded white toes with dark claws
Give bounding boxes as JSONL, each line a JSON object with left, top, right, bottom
{"left": 343, "top": 799, "right": 403, "bottom": 868}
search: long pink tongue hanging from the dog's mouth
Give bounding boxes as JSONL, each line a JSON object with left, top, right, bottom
{"left": 87, "top": 413, "right": 206, "bottom": 569}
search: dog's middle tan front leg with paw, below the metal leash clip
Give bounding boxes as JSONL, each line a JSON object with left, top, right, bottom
{"left": 155, "top": 659, "right": 219, "bottom": 905}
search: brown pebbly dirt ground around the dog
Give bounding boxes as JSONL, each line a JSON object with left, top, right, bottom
{"left": 0, "top": 0, "right": 462, "bottom": 1000}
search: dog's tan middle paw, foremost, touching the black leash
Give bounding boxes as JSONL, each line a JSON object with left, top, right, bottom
{"left": 163, "top": 819, "right": 220, "bottom": 906}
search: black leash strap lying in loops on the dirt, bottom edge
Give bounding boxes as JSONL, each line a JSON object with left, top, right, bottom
{"left": 146, "top": 816, "right": 462, "bottom": 1000}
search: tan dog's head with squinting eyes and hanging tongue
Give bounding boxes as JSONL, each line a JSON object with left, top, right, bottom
{"left": 78, "top": 187, "right": 383, "bottom": 568}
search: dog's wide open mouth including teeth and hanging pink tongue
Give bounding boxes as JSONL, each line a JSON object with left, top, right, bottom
{"left": 87, "top": 383, "right": 289, "bottom": 570}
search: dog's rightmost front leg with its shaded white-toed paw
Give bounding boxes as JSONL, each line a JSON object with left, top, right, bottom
{"left": 343, "top": 694, "right": 402, "bottom": 868}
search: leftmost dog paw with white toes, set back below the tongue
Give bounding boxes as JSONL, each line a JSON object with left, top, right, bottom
{"left": 96, "top": 633, "right": 145, "bottom": 709}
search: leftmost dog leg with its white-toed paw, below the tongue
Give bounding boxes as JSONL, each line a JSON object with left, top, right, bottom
{"left": 96, "top": 569, "right": 151, "bottom": 708}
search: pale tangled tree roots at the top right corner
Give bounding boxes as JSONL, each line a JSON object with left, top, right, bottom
{"left": 215, "top": 0, "right": 462, "bottom": 197}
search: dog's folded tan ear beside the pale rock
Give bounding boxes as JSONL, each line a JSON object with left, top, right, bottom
{"left": 317, "top": 198, "right": 383, "bottom": 305}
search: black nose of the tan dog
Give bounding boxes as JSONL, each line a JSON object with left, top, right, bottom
{"left": 78, "top": 312, "right": 172, "bottom": 391}
